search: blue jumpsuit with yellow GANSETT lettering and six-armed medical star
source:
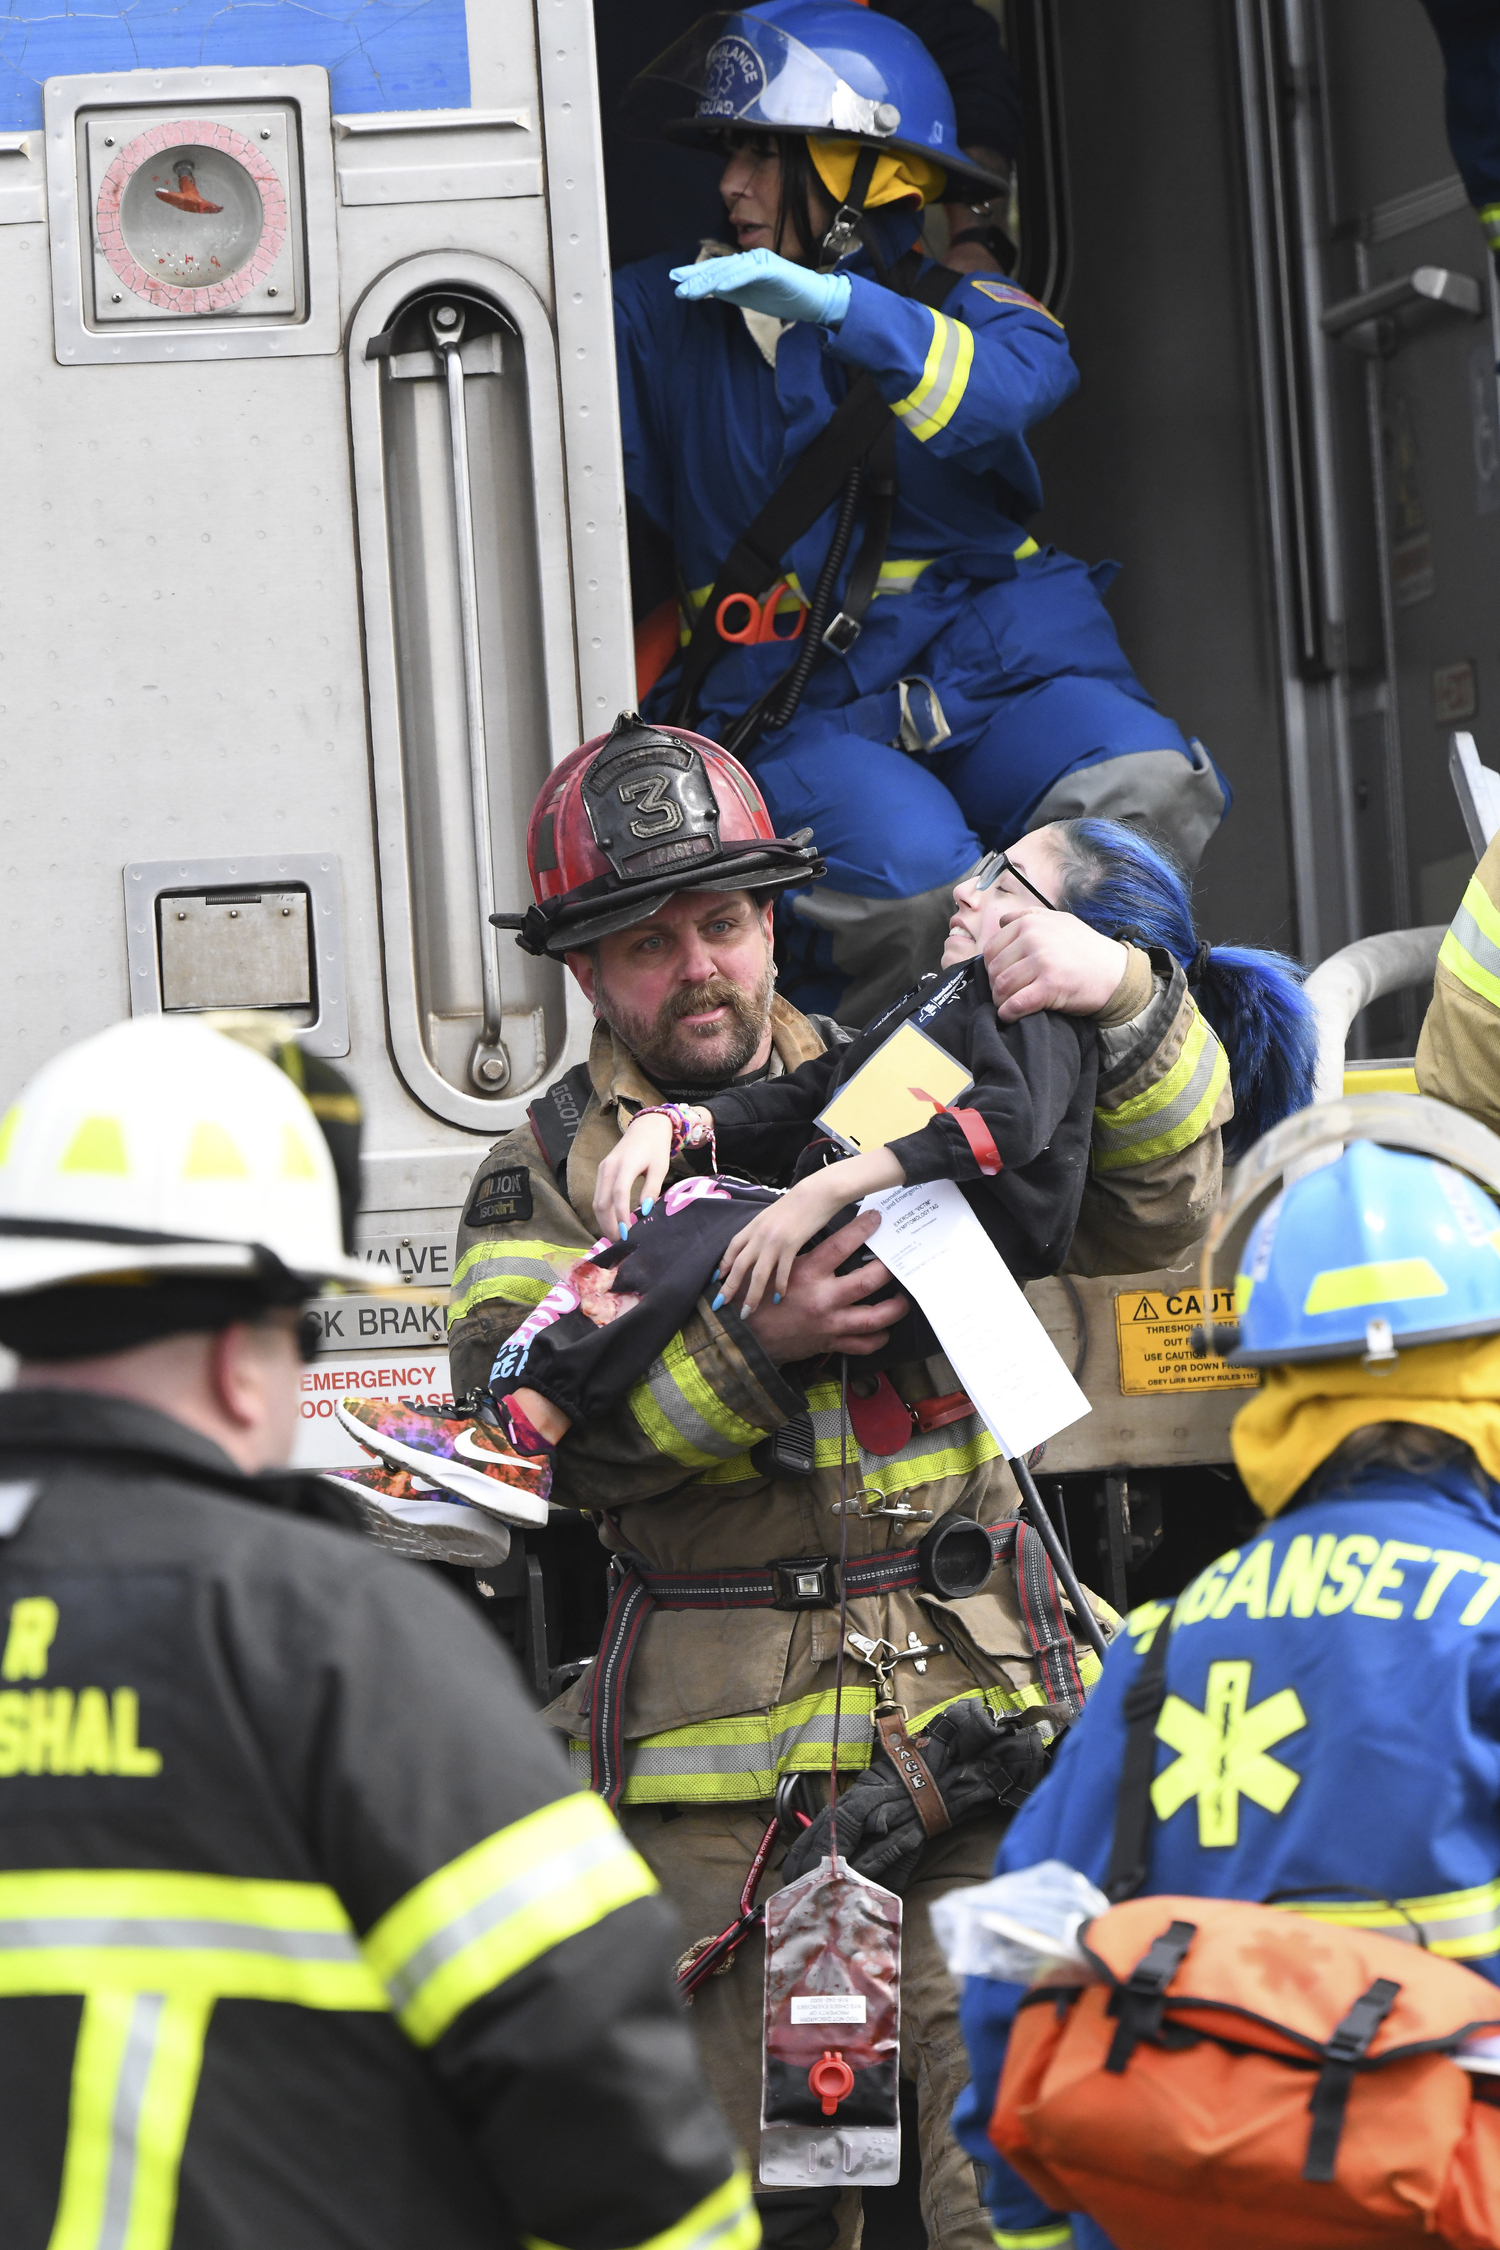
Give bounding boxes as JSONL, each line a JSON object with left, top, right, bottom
{"left": 954, "top": 1469, "right": 1500, "bottom": 2250}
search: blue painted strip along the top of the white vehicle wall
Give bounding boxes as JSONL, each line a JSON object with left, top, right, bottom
{"left": 0, "top": 0, "right": 468, "bottom": 133}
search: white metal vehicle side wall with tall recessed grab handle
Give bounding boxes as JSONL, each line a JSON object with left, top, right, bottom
{"left": 0, "top": 0, "right": 630, "bottom": 1458}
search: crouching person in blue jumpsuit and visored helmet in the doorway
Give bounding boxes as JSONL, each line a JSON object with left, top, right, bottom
{"left": 614, "top": 0, "right": 1228, "bottom": 1022}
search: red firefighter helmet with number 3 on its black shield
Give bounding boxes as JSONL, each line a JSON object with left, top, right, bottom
{"left": 490, "top": 711, "right": 823, "bottom": 956}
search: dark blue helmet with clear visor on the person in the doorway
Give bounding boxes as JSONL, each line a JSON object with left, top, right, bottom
{"left": 641, "top": 0, "right": 1005, "bottom": 194}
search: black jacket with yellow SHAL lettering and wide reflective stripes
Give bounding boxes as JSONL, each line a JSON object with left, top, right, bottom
{"left": 0, "top": 1391, "right": 760, "bottom": 2250}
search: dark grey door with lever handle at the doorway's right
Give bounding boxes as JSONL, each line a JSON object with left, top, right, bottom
{"left": 1237, "top": 0, "right": 1500, "bottom": 1035}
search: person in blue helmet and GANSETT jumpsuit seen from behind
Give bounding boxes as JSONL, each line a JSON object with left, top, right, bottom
{"left": 954, "top": 1096, "right": 1500, "bottom": 2250}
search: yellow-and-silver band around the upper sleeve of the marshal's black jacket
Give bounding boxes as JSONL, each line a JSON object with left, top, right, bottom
{"left": 364, "top": 1791, "right": 657, "bottom": 2048}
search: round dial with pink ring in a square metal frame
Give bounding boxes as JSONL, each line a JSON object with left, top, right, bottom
{"left": 94, "top": 119, "right": 286, "bottom": 313}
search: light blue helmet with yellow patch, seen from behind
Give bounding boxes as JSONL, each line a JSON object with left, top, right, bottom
{"left": 1230, "top": 1143, "right": 1500, "bottom": 1368}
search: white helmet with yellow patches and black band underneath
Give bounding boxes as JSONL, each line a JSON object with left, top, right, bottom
{"left": 0, "top": 1015, "right": 369, "bottom": 1296}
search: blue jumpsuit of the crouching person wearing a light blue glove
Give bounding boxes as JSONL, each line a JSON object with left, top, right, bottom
{"left": 614, "top": 212, "right": 1228, "bottom": 1008}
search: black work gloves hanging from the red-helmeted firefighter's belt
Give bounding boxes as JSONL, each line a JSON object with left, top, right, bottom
{"left": 780, "top": 1697, "right": 1046, "bottom": 1890}
